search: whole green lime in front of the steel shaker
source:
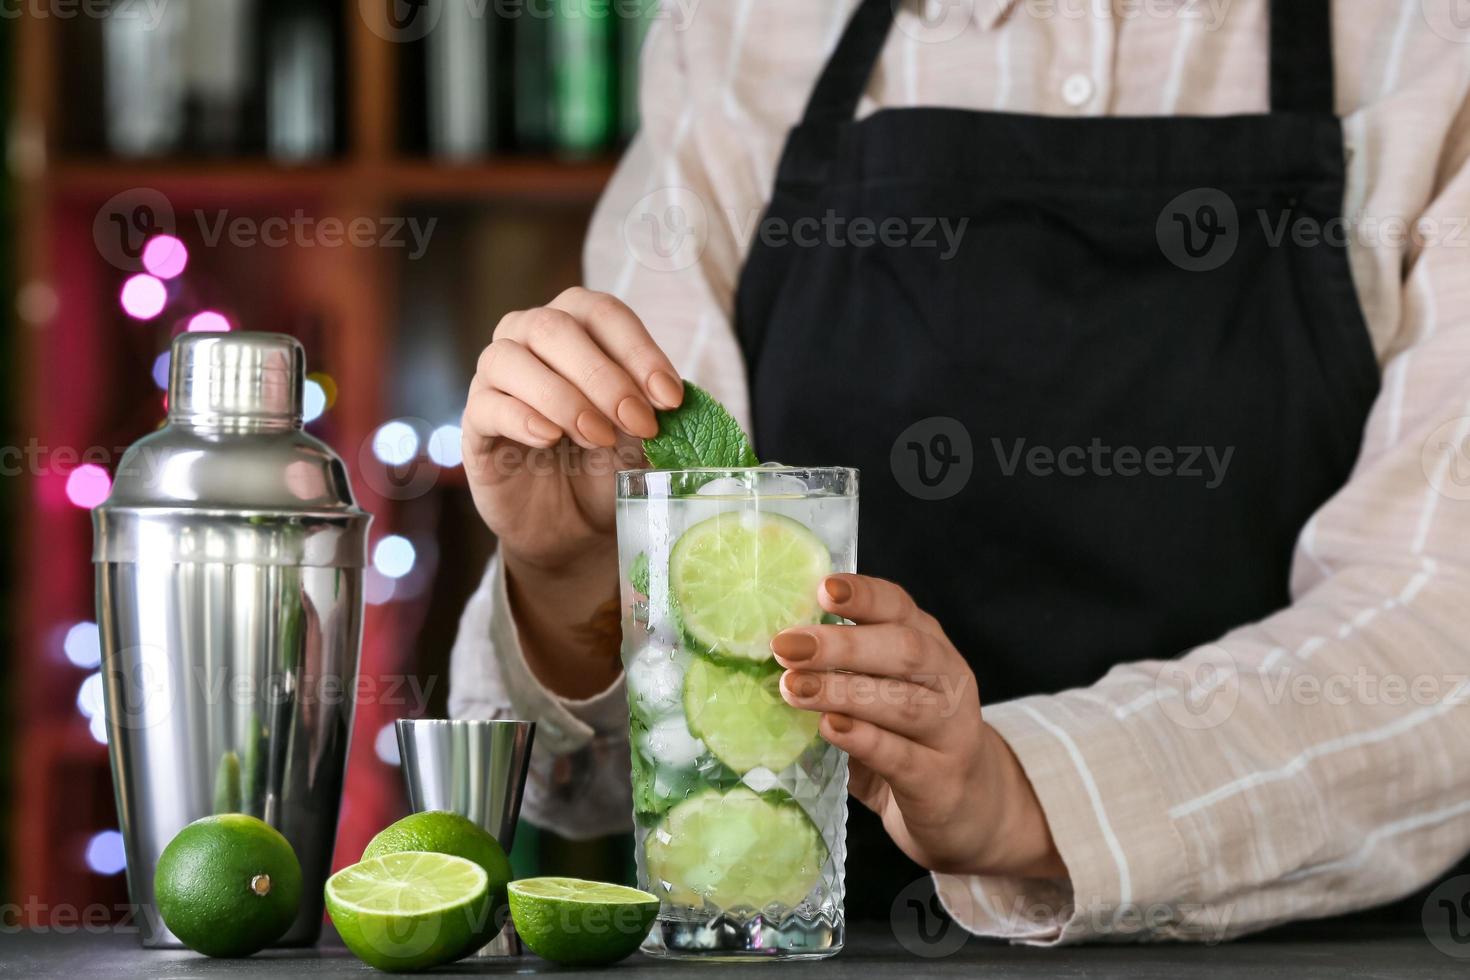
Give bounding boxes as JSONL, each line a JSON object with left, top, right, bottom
{"left": 153, "top": 814, "right": 301, "bottom": 956}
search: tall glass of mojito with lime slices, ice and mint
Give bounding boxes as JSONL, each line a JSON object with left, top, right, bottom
{"left": 617, "top": 466, "right": 857, "bottom": 956}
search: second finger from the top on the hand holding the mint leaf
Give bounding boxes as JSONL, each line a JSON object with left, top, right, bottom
{"left": 495, "top": 307, "right": 659, "bottom": 439}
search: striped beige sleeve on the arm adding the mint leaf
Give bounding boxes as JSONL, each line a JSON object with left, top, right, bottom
{"left": 450, "top": 18, "right": 759, "bottom": 839}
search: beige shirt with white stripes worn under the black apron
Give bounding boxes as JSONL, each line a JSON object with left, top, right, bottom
{"left": 451, "top": 0, "right": 1470, "bottom": 943}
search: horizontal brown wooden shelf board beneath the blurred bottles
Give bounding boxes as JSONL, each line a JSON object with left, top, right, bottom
{"left": 41, "top": 156, "right": 614, "bottom": 206}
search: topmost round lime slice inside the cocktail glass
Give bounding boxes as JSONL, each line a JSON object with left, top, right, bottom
{"left": 669, "top": 510, "right": 832, "bottom": 661}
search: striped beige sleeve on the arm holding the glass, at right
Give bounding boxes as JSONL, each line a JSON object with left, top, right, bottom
{"left": 936, "top": 99, "right": 1470, "bottom": 943}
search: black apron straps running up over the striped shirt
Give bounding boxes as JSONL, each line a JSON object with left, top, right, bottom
{"left": 803, "top": 0, "right": 1333, "bottom": 123}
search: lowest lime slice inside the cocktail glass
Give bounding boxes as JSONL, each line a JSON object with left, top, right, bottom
{"left": 644, "top": 786, "right": 828, "bottom": 911}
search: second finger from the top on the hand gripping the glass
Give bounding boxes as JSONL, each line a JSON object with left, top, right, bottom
{"left": 770, "top": 623, "right": 948, "bottom": 689}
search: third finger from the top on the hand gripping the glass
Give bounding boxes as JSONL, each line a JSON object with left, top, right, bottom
{"left": 781, "top": 670, "right": 953, "bottom": 745}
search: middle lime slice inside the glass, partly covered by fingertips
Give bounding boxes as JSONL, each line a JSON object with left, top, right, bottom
{"left": 684, "top": 657, "right": 822, "bottom": 776}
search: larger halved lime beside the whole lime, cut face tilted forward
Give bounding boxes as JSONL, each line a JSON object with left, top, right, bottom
{"left": 326, "top": 851, "right": 491, "bottom": 973}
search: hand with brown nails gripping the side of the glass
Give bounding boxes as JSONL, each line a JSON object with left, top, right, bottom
{"left": 770, "top": 574, "right": 1066, "bottom": 877}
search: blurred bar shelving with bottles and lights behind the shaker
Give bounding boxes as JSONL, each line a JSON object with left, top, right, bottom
{"left": 0, "top": 0, "right": 656, "bottom": 924}
